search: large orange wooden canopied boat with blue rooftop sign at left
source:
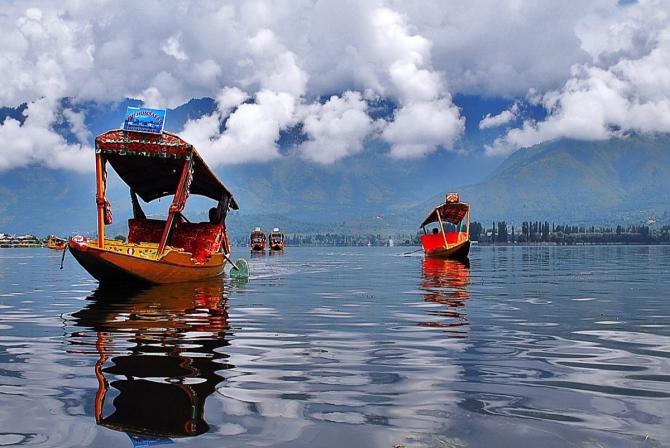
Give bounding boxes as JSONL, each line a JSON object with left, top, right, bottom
{"left": 69, "top": 130, "right": 238, "bottom": 284}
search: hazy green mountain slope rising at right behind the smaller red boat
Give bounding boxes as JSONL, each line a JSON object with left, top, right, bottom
{"left": 414, "top": 135, "right": 670, "bottom": 224}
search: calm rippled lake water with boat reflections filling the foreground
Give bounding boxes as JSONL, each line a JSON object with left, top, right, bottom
{"left": 0, "top": 246, "right": 670, "bottom": 448}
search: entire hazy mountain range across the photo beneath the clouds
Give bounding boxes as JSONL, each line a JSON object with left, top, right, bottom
{"left": 0, "top": 98, "right": 670, "bottom": 235}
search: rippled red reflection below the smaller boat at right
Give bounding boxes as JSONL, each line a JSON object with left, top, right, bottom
{"left": 419, "top": 257, "right": 470, "bottom": 337}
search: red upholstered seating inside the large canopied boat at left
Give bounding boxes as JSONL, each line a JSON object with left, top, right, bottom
{"left": 128, "top": 219, "right": 224, "bottom": 262}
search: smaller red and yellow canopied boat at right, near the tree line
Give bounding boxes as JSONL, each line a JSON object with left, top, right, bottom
{"left": 420, "top": 193, "right": 470, "bottom": 259}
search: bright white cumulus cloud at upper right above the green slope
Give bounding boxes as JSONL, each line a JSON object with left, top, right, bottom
{"left": 486, "top": 1, "right": 670, "bottom": 155}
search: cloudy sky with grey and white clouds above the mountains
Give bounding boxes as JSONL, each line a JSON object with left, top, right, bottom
{"left": 0, "top": 0, "right": 670, "bottom": 170}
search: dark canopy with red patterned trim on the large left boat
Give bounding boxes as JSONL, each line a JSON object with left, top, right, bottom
{"left": 95, "top": 129, "right": 239, "bottom": 210}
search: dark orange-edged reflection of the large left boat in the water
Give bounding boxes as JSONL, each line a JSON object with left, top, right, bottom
{"left": 71, "top": 279, "right": 233, "bottom": 443}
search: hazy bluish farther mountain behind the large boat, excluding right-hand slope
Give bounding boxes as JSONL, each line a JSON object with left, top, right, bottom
{"left": 0, "top": 98, "right": 502, "bottom": 235}
